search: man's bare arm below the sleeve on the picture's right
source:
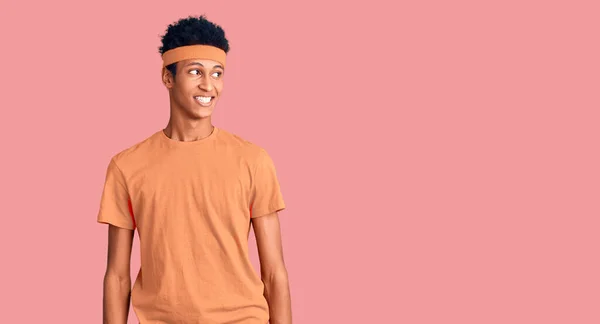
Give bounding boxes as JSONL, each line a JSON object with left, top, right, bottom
{"left": 252, "top": 212, "right": 292, "bottom": 324}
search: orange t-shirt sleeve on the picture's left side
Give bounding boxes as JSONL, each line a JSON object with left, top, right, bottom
{"left": 97, "top": 158, "right": 135, "bottom": 230}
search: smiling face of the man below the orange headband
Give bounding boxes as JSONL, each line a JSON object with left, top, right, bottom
{"left": 163, "top": 59, "right": 224, "bottom": 119}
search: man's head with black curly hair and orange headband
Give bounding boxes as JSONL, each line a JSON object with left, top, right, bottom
{"left": 159, "top": 16, "right": 229, "bottom": 119}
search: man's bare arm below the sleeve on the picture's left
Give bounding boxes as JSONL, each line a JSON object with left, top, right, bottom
{"left": 102, "top": 224, "right": 134, "bottom": 324}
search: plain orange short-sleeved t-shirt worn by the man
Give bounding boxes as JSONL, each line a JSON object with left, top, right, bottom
{"left": 97, "top": 126, "right": 285, "bottom": 324}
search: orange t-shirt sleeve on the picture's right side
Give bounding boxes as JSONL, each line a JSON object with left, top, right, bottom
{"left": 250, "top": 149, "right": 285, "bottom": 218}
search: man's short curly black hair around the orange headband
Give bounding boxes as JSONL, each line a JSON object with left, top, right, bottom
{"left": 158, "top": 15, "right": 229, "bottom": 76}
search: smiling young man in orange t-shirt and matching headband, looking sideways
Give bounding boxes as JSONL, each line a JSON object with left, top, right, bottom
{"left": 97, "top": 16, "right": 292, "bottom": 324}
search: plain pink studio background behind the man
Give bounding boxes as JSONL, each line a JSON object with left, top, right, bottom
{"left": 0, "top": 1, "right": 600, "bottom": 324}
